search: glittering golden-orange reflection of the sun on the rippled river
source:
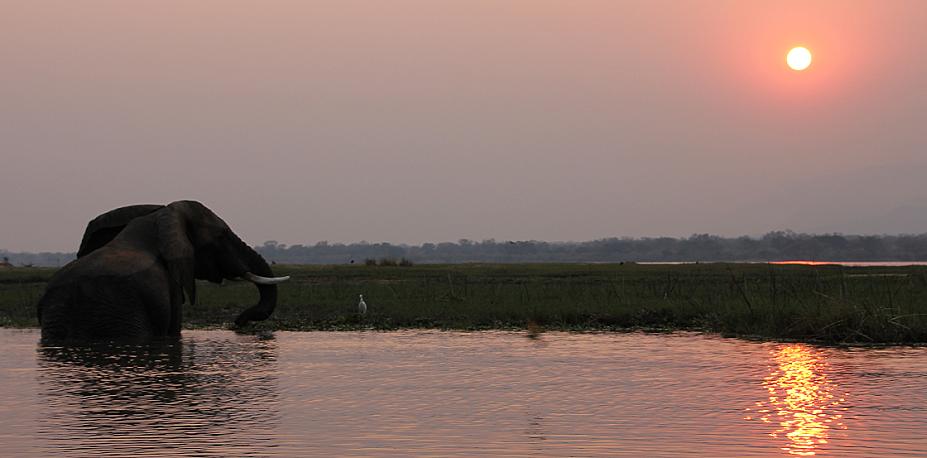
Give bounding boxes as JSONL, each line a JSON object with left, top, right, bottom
{"left": 747, "top": 344, "right": 846, "bottom": 456}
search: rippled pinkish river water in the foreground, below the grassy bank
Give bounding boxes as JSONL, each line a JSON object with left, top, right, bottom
{"left": 0, "top": 329, "right": 927, "bottom": 457}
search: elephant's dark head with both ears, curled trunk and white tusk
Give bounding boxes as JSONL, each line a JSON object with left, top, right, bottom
{"left": 69, "top": 200, "right": 289, "bottom": 332}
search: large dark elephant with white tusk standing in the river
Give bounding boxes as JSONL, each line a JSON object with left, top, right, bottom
{"left": 38, "top": 200, "right": 289, "bottom": 342}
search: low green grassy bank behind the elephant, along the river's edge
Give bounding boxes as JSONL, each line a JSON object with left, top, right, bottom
{"left": 0, "top": 264, "right": 927, "bottom": 343}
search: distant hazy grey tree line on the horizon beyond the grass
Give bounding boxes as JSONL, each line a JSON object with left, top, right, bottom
{"left": 0, "top": 231, "right": 927, "bottom": 267}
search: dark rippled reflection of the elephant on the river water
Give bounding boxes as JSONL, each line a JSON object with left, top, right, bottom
{"left": 38, "top": 336, "right": 279, "bottom": 456}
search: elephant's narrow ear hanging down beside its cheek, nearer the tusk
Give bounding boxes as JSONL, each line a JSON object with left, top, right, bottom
{"left": 156, "top": 208, "right": 196, "bottom": 306}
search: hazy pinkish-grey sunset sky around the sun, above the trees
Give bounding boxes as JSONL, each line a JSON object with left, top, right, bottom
{"left": 0, "top": 0, "right": 927, "bottom": 251}
